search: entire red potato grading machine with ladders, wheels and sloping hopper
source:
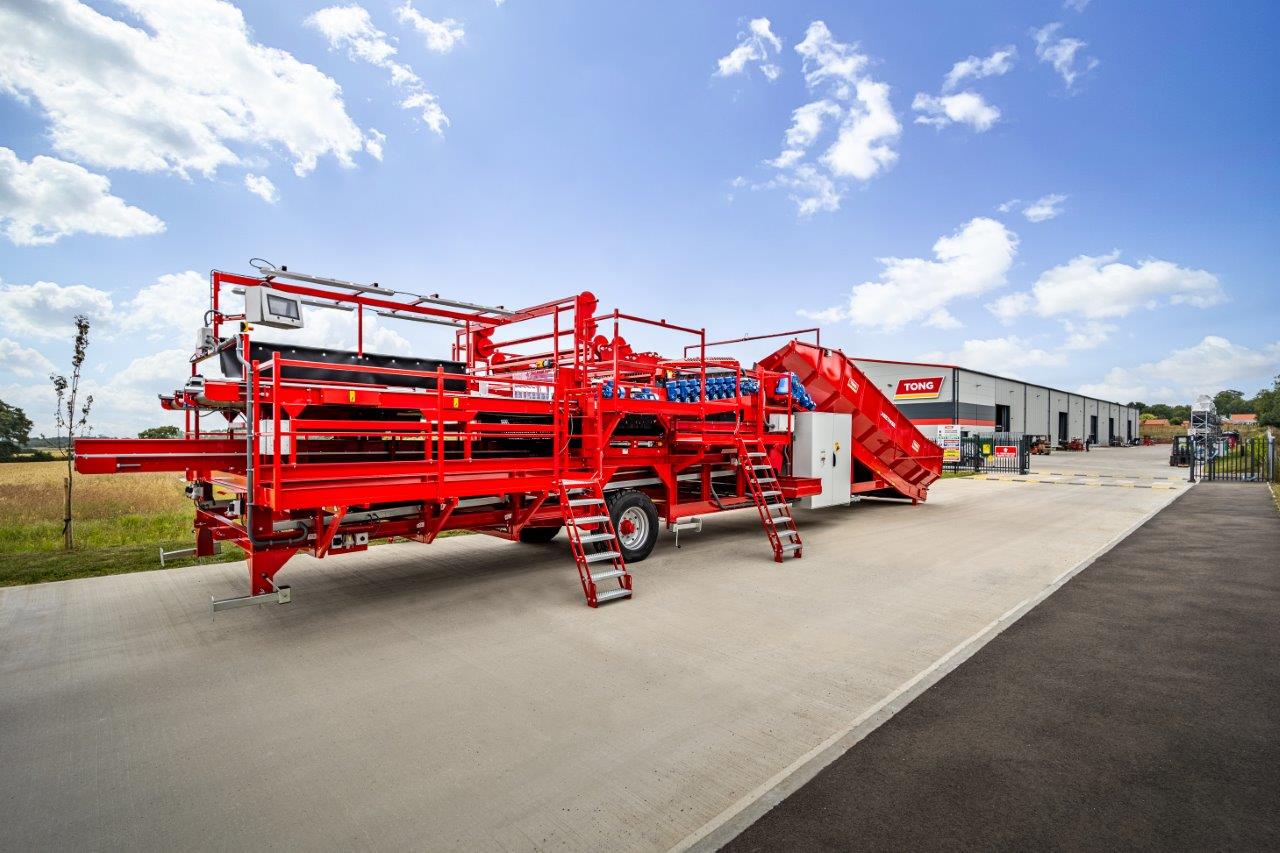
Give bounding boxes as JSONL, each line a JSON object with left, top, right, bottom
{"left": 76, "top": 264, "right": 942, "bottom": 610}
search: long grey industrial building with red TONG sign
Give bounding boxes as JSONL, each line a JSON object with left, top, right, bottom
{"left": 854, "top": 359, "right": 1139, "bottom": 444}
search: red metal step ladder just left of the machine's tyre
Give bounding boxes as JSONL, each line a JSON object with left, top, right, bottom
{"left": 558, "top": 479, "right": 631, "bottom": 607}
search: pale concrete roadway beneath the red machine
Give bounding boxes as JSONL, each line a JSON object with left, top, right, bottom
{"left": 0, "top": 447, "right": 1185, "bottom": 849}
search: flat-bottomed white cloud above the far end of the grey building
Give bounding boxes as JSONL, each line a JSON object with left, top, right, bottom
{"left": 1008, "top": 251, "right": 1226, "bottom": 319}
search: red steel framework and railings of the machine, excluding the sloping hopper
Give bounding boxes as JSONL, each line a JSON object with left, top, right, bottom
{"left": 76, "top": 266, "right": 818, "bottom": 596}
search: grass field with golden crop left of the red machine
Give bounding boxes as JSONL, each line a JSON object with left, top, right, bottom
{"left": 0, "top": 461, "right": 241, "bottom": 587}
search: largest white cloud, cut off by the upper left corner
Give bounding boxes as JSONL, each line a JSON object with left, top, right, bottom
{"left": 0, "top": 0, "right": 362, "bottom": 175}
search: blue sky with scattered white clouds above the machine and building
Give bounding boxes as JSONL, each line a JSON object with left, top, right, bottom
{"left": 0, "top": 0, "right": 1280, "bottom": 435}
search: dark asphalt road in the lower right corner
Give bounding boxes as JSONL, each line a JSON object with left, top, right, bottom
{"left": 724, "top": 483, "right": 1280, "bottom": 853}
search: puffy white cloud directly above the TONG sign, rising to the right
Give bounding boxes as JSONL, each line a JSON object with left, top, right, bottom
{"left": 800, "top": 216, "right": 1018, "bottom": 332}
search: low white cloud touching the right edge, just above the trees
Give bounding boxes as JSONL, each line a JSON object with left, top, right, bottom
{"left": 1080, "top": 334, "right": 1280, "bottom": 402}
